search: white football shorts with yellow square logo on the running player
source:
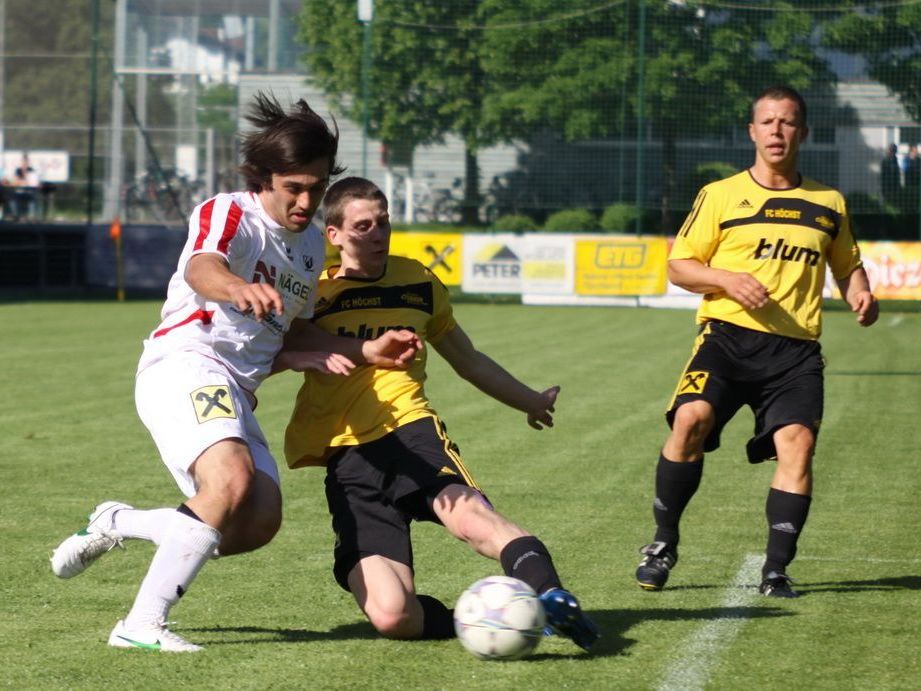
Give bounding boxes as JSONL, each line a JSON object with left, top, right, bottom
{"left": 134, "top": 353, "right": 280, "bottom": 497}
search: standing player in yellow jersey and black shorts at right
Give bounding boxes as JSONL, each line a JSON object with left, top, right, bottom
{"left": 636, "top": 86, "right": 879, "bottom": 597}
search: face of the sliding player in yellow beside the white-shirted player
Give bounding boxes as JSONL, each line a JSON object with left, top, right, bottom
{"left": 326, "top": 199, "right": 390, "bottom": 278}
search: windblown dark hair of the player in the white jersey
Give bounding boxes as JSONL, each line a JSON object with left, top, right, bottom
{"left": 240, "top": 92, "right": 344, "bottom": 192}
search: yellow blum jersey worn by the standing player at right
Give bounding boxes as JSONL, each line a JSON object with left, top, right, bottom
{"left": 669, "top": 170, "right": 861, "bottom": 340}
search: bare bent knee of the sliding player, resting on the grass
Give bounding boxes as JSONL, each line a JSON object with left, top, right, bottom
{"left": 348, "top": 555, "right": 423, "bottom": 640}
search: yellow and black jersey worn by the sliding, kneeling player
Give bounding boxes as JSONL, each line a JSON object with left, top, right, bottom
{"left": 285, "top": 256, "right": 457, "bottom": 468}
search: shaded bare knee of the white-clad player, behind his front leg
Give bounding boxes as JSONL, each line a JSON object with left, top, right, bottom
{"left": 211, "top": 471, "right": 282, "bottom": 557}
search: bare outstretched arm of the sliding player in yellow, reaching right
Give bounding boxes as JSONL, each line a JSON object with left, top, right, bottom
{"left": 432, "top": 326, "right": 560, "bottom": 429}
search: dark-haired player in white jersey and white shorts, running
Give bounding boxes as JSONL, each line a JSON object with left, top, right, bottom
{"left": 51, "top": 94, "right": 421, "bottom": 652}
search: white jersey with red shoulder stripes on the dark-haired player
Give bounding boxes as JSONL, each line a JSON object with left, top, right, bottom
{"left": 138, "top": 192, "right": 325, "bottom": 392}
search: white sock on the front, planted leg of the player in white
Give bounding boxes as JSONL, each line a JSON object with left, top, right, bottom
{"left": 125, "top": 510, "right": 221, "bottom": 629}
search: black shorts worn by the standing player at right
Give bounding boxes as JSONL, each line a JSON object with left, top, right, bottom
{"left": 665, "top": 320, "right": 825, "bottom": 463}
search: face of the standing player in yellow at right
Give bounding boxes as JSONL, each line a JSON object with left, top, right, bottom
{"left": 748, "top": 98, "right": 809, "bottom": 171}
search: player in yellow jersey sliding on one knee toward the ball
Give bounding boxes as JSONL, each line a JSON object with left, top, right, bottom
{"left": 285, "top": 178, "right": 598, "bottom": 649}
